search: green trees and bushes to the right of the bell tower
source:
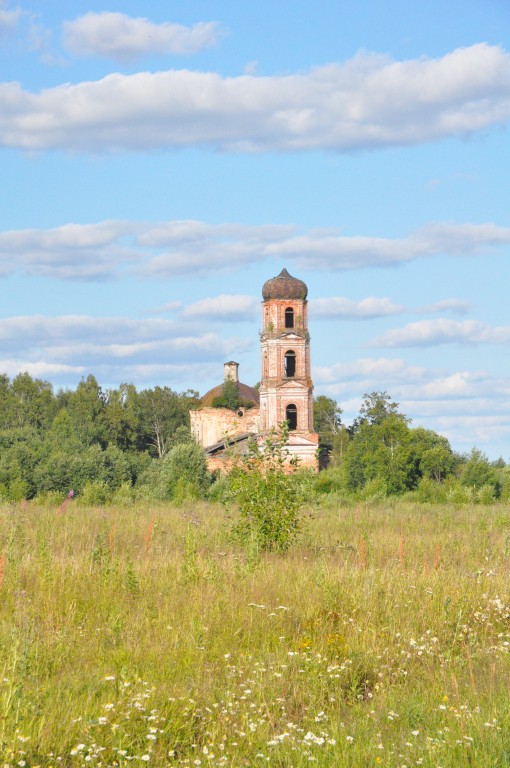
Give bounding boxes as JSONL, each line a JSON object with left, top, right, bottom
{"left": 314, "top": 392, "right": 510, "bottom": 502}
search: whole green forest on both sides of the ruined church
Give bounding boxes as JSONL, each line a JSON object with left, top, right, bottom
{"left": 0, "top": 373, "right": 510, "bottom": 504}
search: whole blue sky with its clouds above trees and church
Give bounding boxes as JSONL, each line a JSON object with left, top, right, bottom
{"left": 0, "top": 0, "right": 510, "bottom": 460}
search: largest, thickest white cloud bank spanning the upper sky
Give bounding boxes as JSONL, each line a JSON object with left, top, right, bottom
{"left": 0, "top": 43, "right": 510, "bottom": 152}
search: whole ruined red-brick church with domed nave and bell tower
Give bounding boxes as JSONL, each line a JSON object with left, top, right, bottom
{"left": 190, "top": 269, "right": 319, "bottom": 470}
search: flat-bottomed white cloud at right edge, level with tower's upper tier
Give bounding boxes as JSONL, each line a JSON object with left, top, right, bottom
{"left": 372, "top": 319, "right": 510, "bottom": 347}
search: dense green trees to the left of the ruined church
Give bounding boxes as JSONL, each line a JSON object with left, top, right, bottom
{"left": 0, "top": 373, "right": 200, "bottom": 501}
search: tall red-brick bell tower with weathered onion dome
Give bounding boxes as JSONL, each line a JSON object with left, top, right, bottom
{"left": 259, "top": 269, "right": 318, "bottom": 465}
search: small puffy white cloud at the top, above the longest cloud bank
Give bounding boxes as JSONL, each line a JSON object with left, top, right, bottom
{"left": 63, "top": 11, "right": 220, "bottom": 61}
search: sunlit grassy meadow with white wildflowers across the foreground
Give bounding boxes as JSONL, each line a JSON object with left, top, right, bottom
{"left": 0, "top": 500, "right": 510, "bottom": 768}
